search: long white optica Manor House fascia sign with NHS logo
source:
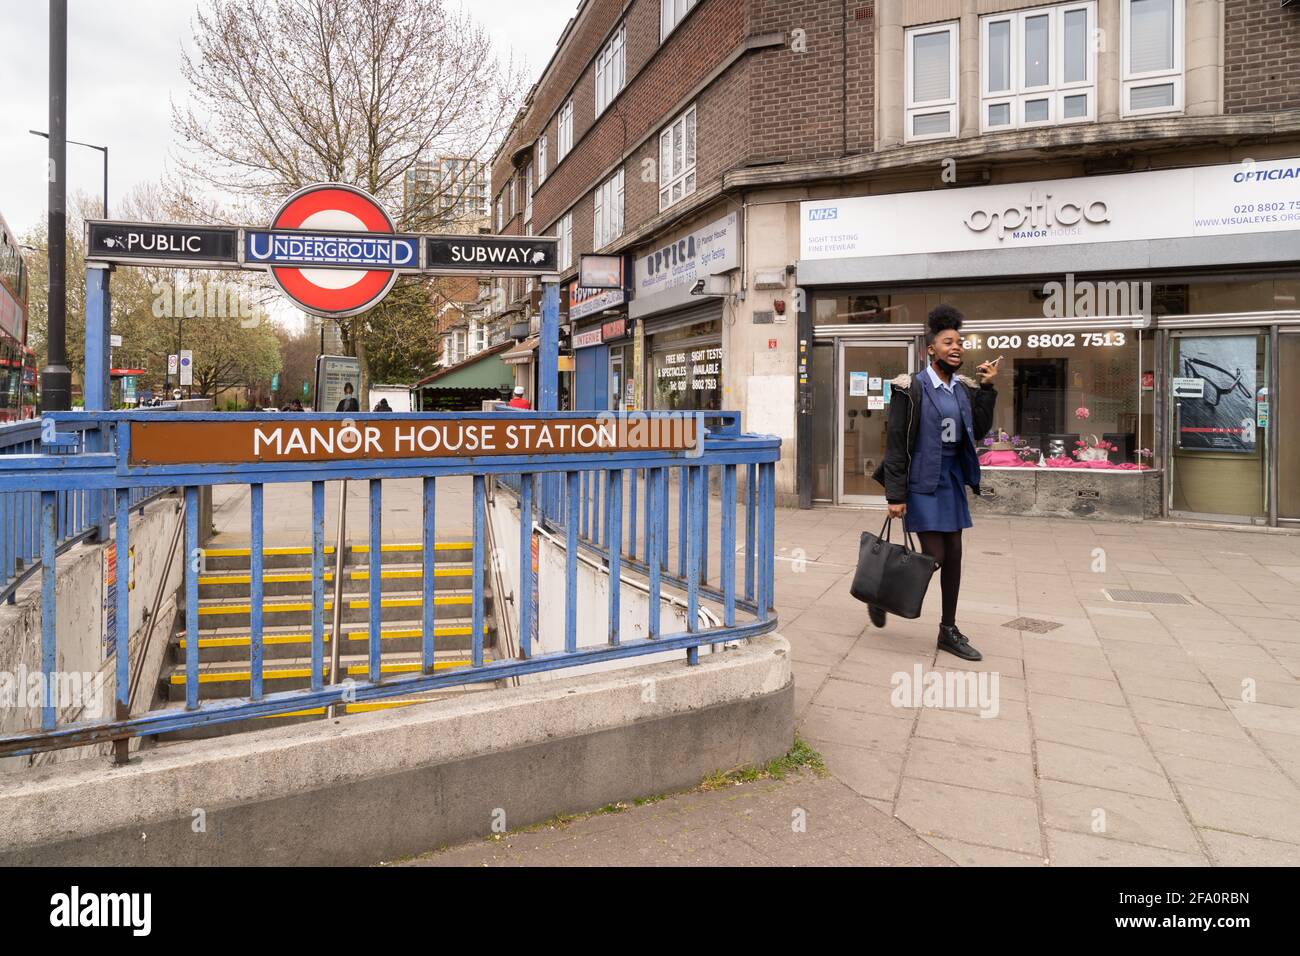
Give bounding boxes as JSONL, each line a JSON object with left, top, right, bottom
{"left": 800, "top": 159, "right": 1300, "bottom": 260}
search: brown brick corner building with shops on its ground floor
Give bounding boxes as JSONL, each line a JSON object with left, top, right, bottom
{"left": 491, "top": 0, "right": 1300, "bottom": 523}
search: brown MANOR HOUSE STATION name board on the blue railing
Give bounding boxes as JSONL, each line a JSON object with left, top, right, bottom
{"left": 127, "top": 414, "right": 705, "bottom": 467}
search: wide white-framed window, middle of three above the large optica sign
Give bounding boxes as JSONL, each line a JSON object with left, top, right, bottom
{"left": 980, "top": 0, "right": 1097, "bottom": 133}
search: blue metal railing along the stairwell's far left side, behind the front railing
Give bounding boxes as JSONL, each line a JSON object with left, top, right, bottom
{"left": 0, "top": 419, "right": 169, "bottom": 604}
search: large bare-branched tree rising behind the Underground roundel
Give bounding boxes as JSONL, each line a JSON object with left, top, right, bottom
{"left": 173, "top": 0, "right": 523, "bottom": 389}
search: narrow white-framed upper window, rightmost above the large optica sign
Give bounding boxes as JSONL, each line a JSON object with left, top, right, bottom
{"left": 1121, "top": 0, "right": 1183, "bottom": 116}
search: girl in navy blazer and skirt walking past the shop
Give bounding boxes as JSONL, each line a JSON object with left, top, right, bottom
{"left": 868, "top": 306, "right": 1001, "bottom": 661}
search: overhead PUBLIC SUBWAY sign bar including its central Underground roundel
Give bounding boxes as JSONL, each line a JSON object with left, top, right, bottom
{"left": 86, "top": 182, "right": 559, "bottom": 319}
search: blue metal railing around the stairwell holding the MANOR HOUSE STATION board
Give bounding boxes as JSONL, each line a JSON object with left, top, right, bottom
{"left": 0, "top": 411, "right": 780, "bottom": 756}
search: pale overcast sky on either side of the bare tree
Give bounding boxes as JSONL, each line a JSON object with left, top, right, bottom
{"left": 0, "top": 0, "right": 579, "bottom": 235}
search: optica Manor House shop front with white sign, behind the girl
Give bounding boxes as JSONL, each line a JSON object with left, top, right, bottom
{"left": 798, "top": 160, "right": 1300, "bottom": 523}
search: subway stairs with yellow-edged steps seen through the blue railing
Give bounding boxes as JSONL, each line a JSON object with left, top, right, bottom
{"left": 160, "top": 541, "right": 497, "bottom": 740}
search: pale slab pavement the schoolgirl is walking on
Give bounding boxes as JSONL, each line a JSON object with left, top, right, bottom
{"left": 205, "top": 479, "right": 1300, "bottom": 866}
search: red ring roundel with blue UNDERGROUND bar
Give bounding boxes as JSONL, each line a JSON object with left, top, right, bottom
{"left": 243, "top": 182, "right": 419, "bottom": 317}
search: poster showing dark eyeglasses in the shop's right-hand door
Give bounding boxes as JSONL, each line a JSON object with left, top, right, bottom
{"left": 1173, "top": 336, "right": 1256, "bottom": 454}
